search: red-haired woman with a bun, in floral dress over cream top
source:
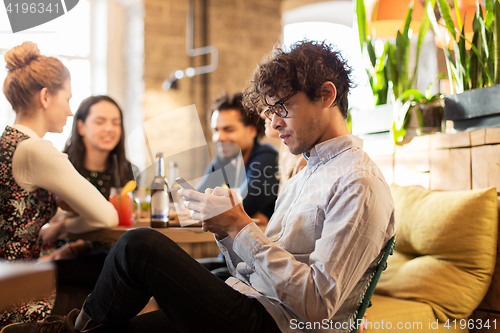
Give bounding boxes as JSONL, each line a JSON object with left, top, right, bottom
{"left": 0, "top": 42, "right": 118, "bottom": 326}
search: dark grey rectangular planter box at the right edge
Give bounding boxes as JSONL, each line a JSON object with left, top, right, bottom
{"left": 444, "top": 84, "right": 500, "bottom": 131}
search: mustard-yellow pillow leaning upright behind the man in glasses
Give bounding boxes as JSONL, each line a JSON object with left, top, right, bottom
{"left": 376, "top": 185, "right": 498, "bottom": 321}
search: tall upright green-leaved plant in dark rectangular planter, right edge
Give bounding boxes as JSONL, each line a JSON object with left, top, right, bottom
{"left": 426, "top": 0, "right": 500, "bottom": 130}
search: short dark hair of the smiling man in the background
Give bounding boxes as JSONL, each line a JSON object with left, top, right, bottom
{"left": 209, "top": 92, "right": 266, "bottom": 138}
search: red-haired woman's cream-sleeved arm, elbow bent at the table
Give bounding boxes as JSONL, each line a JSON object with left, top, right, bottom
{"left": 12, "top": 124, "right": 118, "bottom": 234}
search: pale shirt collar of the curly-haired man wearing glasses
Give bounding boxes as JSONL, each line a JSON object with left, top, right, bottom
{"left": 303, "top": 134, "right": 363, "bottom": 167}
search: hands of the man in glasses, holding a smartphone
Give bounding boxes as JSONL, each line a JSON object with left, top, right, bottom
{"left": 178, "top": 187, "right": 252, "bottom": 239}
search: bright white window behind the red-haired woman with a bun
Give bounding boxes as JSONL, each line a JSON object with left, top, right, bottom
{"left": 0, "top": 0, "right": 100, "bottom": 150}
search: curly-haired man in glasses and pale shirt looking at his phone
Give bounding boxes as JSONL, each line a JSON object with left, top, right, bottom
{"left": 4, "top": 41, "right": 395, "bottom": 332}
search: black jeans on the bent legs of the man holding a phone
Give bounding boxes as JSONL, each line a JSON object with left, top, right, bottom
{"left": 85, "top": 228, "right": 280, "bottom": 333}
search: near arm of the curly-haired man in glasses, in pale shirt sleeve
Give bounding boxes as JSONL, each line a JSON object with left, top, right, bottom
{"left": 234, "top": 175, "right": 393, "bottom": 321}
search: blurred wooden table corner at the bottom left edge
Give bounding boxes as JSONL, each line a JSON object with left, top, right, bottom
{"left": 0, "top": 261, "right": 56, "bottom": 312}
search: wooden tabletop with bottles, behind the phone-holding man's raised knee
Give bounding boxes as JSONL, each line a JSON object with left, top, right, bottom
{"left": 67, "top": 219, "right": 266, "bottom": 259}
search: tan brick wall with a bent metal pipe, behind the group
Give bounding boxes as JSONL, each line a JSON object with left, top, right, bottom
{"left": 143, "top": 0, "right": 282, "bottom": 180}
